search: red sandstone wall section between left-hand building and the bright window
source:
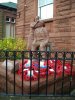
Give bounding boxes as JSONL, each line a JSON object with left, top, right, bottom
{"left": 16, "top": 0, "right": 35, "bottom": 38}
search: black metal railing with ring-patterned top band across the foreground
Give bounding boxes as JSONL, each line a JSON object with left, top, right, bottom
{"left": 0, "top": 51, "right": 75, "bottom": 97}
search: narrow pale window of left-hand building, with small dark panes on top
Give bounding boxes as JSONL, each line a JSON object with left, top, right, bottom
{"left": 6, "top": 16, "right": 15, "bottom": 38}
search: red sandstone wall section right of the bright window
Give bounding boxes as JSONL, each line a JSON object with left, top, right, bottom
{"left": 54, "top": 0, "right": 75, "bottom": 51}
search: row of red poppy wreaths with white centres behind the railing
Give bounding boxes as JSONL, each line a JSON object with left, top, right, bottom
{"left": 17, "top": 59, "right": 74, "bottom": 81}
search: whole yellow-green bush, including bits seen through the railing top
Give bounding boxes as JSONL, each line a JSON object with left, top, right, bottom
{"left": 0, "top": 38, "right": 27, "bottom": 59}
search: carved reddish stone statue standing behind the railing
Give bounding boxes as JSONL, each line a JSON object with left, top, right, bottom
{"left": 28, "top": 16, "right": 49, "bottom": 57}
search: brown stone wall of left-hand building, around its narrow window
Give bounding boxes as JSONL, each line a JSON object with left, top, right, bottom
{"left": 0, "top": 7, "right": 17, "bottom": 39}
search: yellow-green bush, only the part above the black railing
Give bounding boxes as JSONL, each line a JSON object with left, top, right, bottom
{"left": 0, "top": 38, "right": 27, "bottom": 50}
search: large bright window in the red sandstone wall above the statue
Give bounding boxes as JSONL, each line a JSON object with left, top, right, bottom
{"left": 38, "top": 0, "right": 53, "bottom": 19}
